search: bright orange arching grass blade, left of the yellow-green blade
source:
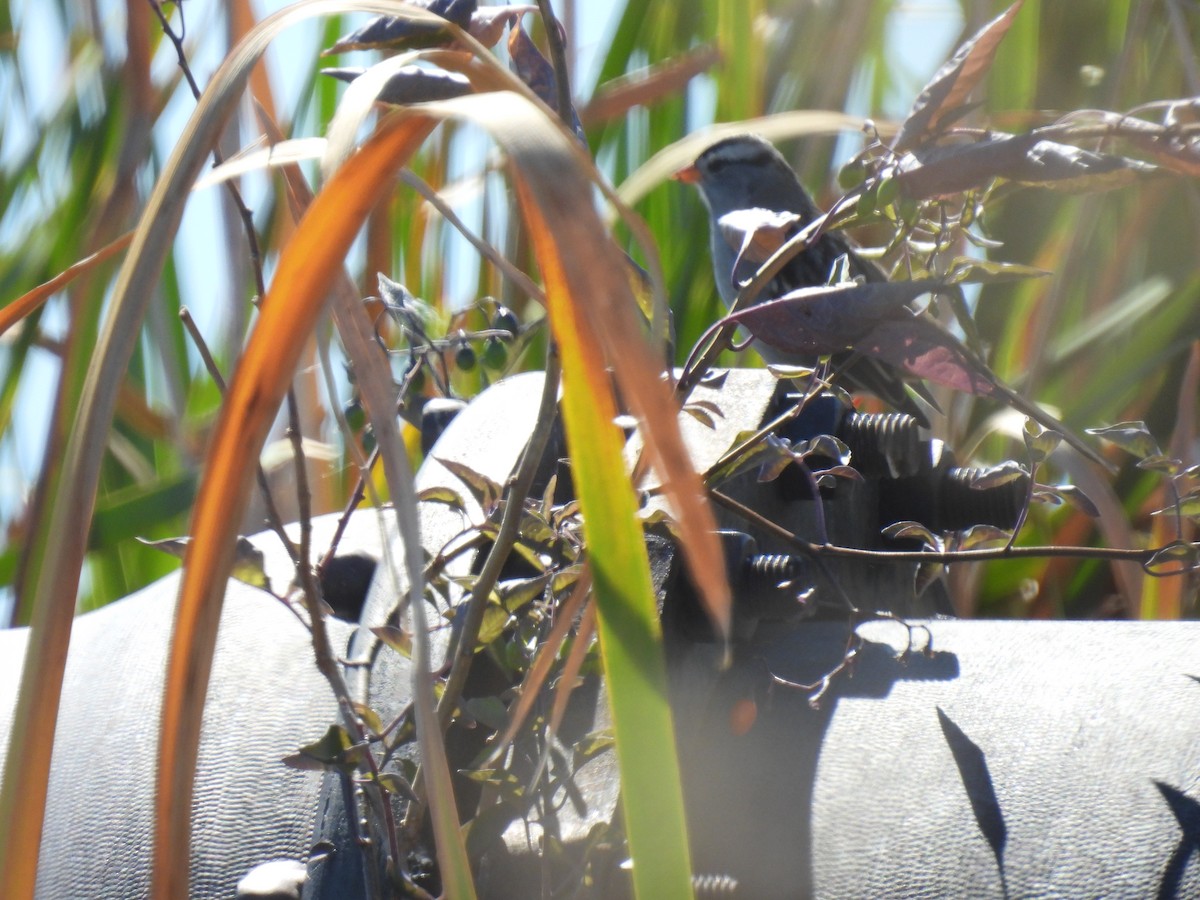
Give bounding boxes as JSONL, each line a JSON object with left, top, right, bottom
{"left": 154, "top": 118, "right": 457, "bottom": 898}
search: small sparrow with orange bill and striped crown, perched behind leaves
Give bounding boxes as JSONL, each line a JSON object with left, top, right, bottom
{"left": 674, "top": 134, "right": 936, "bottom": 426}
